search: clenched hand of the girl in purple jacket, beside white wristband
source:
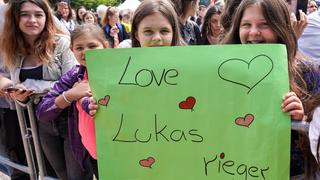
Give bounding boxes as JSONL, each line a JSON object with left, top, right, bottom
{"left": 67, "top": 80, "right": 92, "bottom": 101}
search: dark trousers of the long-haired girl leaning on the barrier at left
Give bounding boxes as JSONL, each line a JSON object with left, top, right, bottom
{"left": 38, "top": 114, "right": 93, "bottom": 180}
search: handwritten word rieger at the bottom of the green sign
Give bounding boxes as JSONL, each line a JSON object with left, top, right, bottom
{"left": 203, "top": 153, "right": 269, "bottom": 180}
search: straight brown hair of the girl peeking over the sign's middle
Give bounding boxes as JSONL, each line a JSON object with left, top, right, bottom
{"left": 131, "top": 0, "right": 183, "bottom": 47}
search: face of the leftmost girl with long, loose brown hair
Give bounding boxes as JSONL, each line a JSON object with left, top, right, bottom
{"left": 19, "top": 2, "right": 46, "bottom": 39}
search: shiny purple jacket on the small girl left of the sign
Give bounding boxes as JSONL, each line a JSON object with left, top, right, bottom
{"left": 36, "top": 65, "right": 89, "bottom": 168}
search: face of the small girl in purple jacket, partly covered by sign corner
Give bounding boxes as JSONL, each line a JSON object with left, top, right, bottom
{"left": 72, "top": 33, "right": 107, "bottom": 66}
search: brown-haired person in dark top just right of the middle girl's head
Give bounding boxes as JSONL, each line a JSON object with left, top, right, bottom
{"left": 172, "top": 0, "right": 201, "bottom": 45}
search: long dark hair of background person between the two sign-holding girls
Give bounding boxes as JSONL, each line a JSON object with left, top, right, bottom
{"left": 201, "top": 6, "right": 221, "bottom": 42}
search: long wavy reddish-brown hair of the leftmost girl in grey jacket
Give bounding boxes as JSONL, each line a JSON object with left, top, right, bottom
{"left": 0, "top": 0, "right": 57, "bottom": 69}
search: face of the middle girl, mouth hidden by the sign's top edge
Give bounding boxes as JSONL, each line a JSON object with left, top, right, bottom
{"left": 135, "top": 13, "right": 173, "bottom": 47}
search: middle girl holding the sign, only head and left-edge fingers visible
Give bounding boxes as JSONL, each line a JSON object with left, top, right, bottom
{"left": 89, "top": 0, "right": 185, "bottom": 115}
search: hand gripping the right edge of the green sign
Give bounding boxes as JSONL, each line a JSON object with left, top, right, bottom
{"left": 281, "top": 92, "right": 304, "bottom": 120}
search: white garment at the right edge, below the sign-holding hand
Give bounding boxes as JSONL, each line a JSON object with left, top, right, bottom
{"left": 309, "top": 106, "right": 320, "bottom": 161}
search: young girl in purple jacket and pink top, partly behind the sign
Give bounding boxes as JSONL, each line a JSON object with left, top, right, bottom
{"left": 36, "top": 24, "right": 108, "bottom": 179}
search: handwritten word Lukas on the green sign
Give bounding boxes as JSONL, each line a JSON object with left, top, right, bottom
{"left": 113, "top": 114, "right": 203, "bottom": 143}
